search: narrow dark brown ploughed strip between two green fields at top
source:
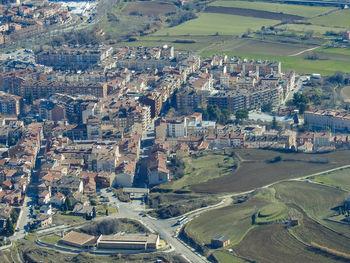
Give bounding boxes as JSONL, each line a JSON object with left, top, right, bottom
{"left": 205, "top": 6, "right": 305, "bottom": 21}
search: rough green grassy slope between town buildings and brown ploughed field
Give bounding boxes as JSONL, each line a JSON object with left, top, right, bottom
{"left": 160, "top": 151, "right": 234, "bottom": 190}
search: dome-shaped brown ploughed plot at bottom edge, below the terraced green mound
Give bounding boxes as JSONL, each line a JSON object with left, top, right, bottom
{"left": 234, "top": 224, "right": 339, "bottom": 263}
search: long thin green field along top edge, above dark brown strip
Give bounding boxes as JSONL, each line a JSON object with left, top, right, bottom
{"left": 210, "top": 0, "right": 335, "bottom": 17}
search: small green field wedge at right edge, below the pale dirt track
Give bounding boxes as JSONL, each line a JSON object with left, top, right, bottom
{"left": 313, "top": 168, "right": 350, "bottom": 191}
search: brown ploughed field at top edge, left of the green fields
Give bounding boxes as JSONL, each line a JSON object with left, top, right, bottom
{"left": 123, "top": 1, "right": 176, "bottom": 16}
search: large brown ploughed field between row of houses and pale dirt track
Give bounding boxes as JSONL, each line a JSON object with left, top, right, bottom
{"left": 191, "top": 149, "right": 350, "bottom": 193}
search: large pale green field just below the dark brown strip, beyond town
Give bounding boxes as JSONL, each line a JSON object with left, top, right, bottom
{"left": 155, "top": 13, "right": 279, "bottom": 36}
